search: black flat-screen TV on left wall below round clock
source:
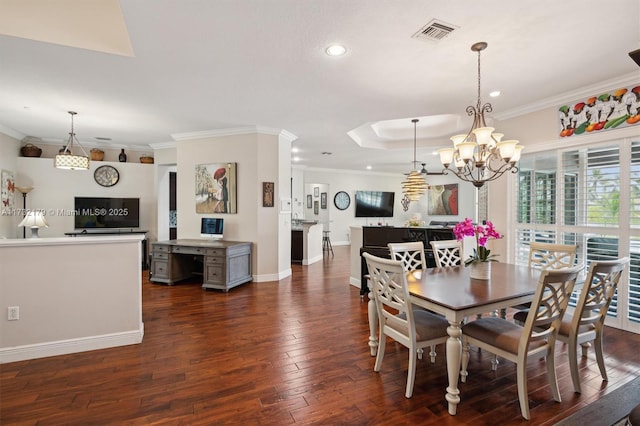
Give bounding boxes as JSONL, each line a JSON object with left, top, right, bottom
{"left": 74, "top": 197, "right": 140, "bottom": 229}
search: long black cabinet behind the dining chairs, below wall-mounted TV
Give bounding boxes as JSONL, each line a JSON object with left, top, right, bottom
{"left": 360, "top": 226, "right": 456, "bottom": 296}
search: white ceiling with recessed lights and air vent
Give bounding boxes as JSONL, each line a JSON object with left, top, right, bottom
{"left": 0, "top": 0, "right": 640, "bottom": 172}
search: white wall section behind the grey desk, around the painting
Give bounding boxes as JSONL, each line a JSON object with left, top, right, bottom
{"left": 172, "top": 131, "right": 291, "bottom": 281}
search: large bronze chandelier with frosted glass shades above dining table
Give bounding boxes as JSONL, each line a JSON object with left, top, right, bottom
{"left": 438, "top": 42, "right": 524, "bottom": 188}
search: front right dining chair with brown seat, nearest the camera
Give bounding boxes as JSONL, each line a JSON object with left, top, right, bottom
{"left": 460, "top": 266, "right": 582, "bottom": 420}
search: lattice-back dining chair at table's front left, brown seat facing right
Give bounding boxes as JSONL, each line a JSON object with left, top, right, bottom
{"left": 363, "top": 253, "right": 449, "bottom": 398}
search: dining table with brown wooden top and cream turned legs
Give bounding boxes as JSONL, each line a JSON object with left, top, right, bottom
{"left": 368, "top": 262, "right": 541, "bottom": 415}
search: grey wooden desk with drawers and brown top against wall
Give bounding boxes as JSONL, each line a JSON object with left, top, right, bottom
{"left": 150, "top": 239, "right": 252, "bottom": 291}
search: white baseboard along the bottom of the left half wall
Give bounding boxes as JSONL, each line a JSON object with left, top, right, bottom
{"left": 0, "top": 324, "right": 144, "bottom": 364}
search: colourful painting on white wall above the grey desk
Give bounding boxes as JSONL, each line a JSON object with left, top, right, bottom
{"left": 195, "top": 163, "right": 238, "bottom": 213}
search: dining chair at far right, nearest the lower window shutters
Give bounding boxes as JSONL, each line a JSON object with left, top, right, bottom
{"left": 558, "top": 257, "right": 629, "bottom": 393}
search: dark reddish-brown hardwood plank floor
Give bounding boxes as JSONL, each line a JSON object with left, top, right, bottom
{"left": 0, "top": 246, "right": 640, "bottom": 425}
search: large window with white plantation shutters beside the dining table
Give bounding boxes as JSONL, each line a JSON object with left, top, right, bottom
{"left": 513, "top": 139, "right": 640, "bottom": 332}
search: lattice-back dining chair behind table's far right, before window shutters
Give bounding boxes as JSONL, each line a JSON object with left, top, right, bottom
{"left": 502, "top": 241, "right": 578, "bottom": 325}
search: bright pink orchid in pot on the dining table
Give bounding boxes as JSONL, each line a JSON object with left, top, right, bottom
{"left": 453, "top": 218, "right": 502, "bottom": 280}
